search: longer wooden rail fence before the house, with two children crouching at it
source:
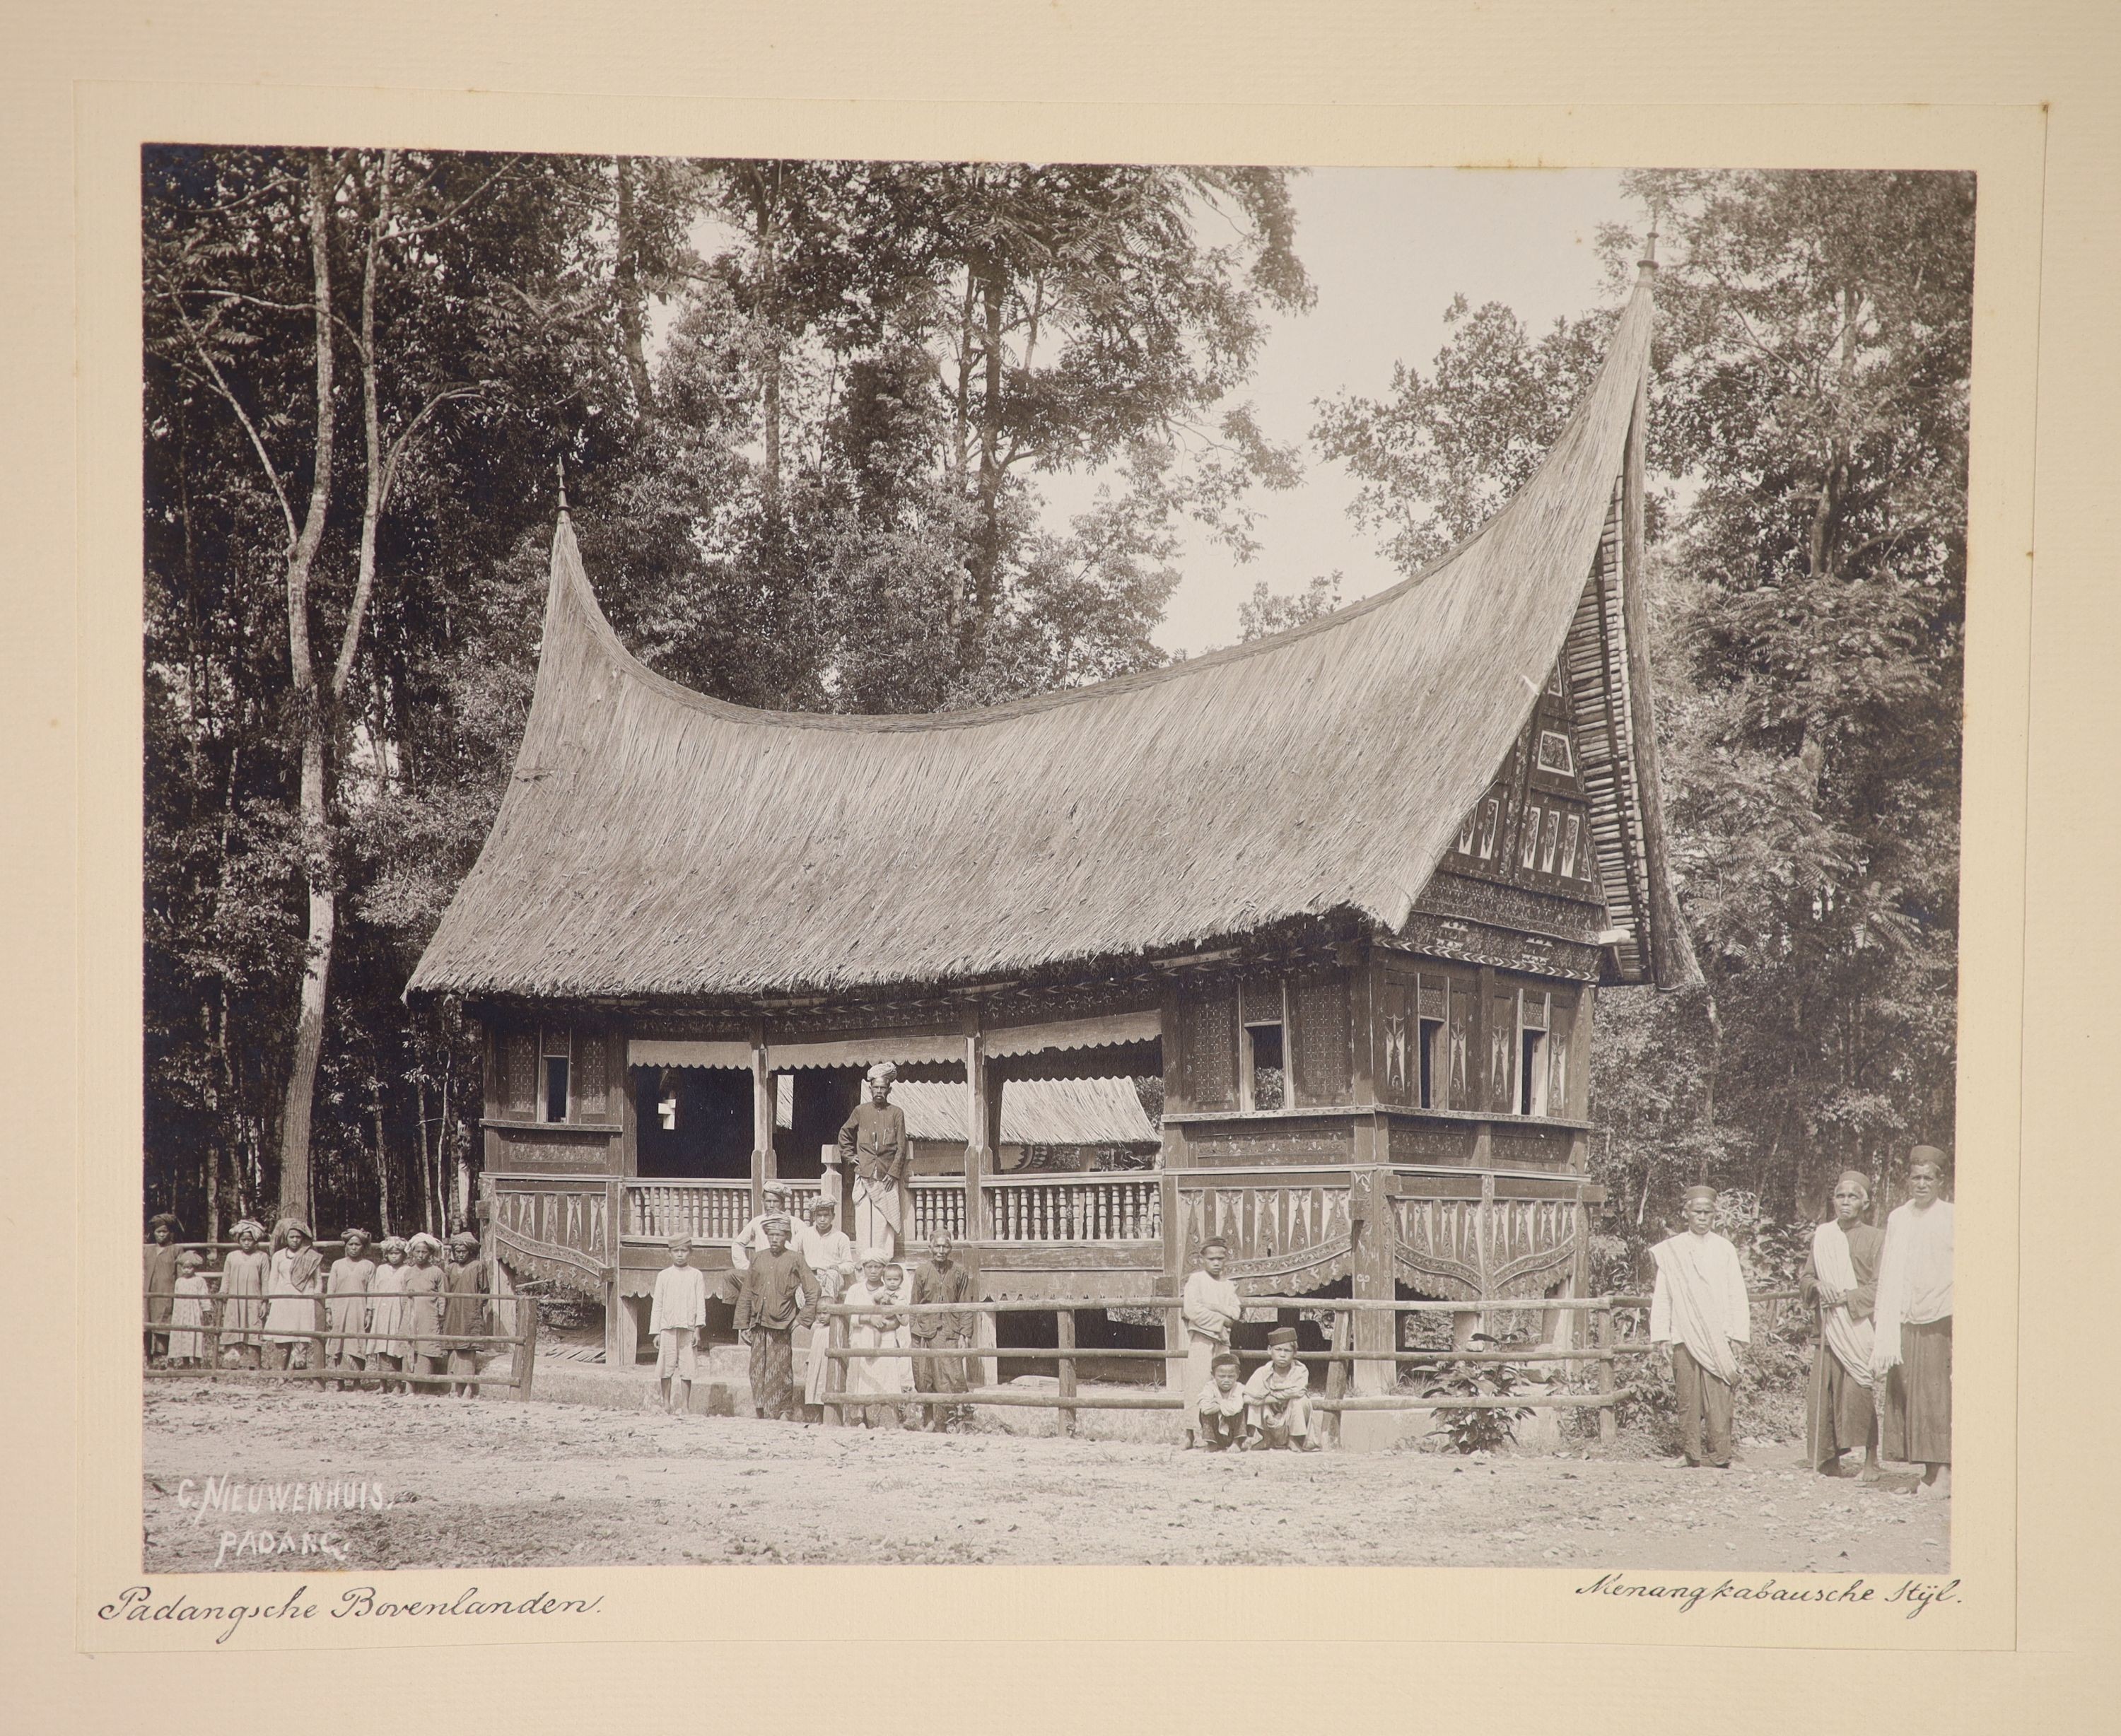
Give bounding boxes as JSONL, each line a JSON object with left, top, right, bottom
{"left": 817, "top": 1291, "right": 1796, "bottom": 1441}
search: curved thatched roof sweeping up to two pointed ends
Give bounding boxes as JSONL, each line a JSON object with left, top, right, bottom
{"left": 409, "top": 271, "right": 1650, "bottom": 1000}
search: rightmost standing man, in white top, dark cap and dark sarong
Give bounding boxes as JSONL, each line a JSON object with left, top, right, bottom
{"left": 1871, "top": 1144, "right": 1951, "bottom": 1499}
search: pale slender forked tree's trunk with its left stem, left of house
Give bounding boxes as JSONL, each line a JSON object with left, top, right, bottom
{"left": 280, "top": 153, "right": 337, "bottom": 1216}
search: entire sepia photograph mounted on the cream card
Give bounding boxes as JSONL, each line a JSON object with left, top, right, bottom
{"left": 141, "top": 144, "right": 1968, "bottom": 1590}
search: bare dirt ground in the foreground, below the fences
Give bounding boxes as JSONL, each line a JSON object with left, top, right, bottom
{"left": 144, "top": 1384, "right": 1949, "bottom": 1573}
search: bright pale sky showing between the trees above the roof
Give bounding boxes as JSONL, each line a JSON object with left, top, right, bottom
{"left": 1128, "top": 170, "right": 1642, "bottom": 651}
